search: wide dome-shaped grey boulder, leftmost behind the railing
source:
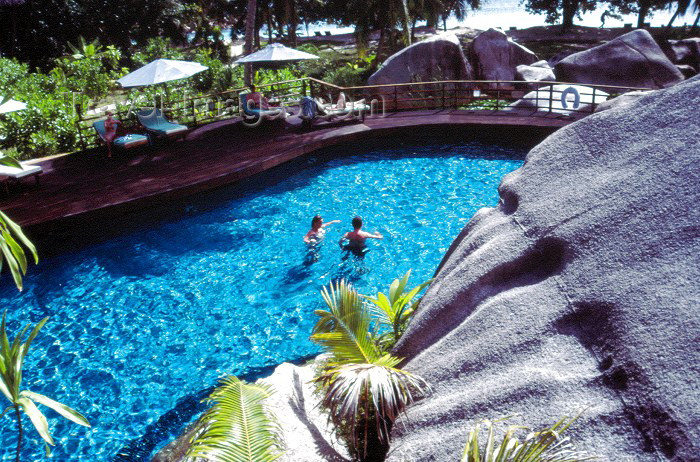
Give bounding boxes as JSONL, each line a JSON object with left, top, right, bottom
{"left": 367, "top": 34, "right": 472, "bottom": 85}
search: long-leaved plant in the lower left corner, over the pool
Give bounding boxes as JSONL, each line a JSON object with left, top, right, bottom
{"left": 0, "top": 313, "right": 90, "bottom": 462}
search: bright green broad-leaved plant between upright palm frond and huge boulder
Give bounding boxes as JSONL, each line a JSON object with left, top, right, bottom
{"left": 364, "top": 270, "right": 433, "bottom": 350}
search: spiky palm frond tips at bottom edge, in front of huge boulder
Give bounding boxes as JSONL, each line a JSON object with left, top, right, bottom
{"left": 460, "top": 414, "right": 597, "bottom": 462}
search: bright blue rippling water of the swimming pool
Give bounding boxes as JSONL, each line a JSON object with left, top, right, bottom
{"left": 0, "top": 142, "right": 525, "bottom": 461}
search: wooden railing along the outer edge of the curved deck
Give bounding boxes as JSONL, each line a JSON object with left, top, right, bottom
{"left": 76, "top": 77, "right": 649, "bottom": 149}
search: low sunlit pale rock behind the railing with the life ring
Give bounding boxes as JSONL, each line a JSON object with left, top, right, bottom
{"left": 504, "top": 85, "right": 609, "bottom": 114}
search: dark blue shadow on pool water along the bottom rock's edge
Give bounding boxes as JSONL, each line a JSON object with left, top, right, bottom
{"left": 112, "top": 355, "right": 316, "bottom": 462}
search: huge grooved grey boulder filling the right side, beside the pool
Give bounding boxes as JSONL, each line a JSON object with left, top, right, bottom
{"left": 389, "top": 77, "right": 700, "bottom": 462}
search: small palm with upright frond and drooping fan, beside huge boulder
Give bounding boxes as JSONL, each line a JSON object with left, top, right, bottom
{"left": 311, "top": 281, "right": 430, "bottom": 460}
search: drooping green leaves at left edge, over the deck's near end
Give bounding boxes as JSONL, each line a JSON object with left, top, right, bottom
{"left": 0, "top": 208, "right": 39, "bottom": 291}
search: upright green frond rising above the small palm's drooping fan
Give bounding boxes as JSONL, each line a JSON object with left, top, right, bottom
{"left": 311, "top": 280, "right": 381, "bottom": 364}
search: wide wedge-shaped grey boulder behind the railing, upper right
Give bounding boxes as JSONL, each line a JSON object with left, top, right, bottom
{"left": 554, "top": 29, "right": 684, "bottom": 88}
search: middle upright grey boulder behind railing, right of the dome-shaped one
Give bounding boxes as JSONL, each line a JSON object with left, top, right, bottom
{"left": 469, "top": 29, "right": 537, "bottom": 87}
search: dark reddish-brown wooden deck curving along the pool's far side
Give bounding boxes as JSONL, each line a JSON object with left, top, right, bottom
{"left": 0, "top": 110, "right": 573, "bottom": 237}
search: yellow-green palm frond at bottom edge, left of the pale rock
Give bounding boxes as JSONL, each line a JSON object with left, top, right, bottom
{"left": 187, "top": 376, "right": 283, "bottom": 462}
